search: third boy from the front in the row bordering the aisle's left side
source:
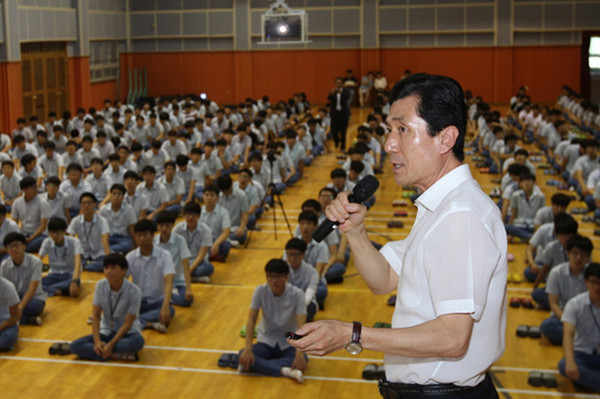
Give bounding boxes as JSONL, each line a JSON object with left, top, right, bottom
{"left": 154, "top": 211, "right": 194, "bottom": 307}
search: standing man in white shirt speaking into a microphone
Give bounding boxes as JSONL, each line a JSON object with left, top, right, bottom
{"left": 288, "top": 74, "right": 507, "bottom": 399}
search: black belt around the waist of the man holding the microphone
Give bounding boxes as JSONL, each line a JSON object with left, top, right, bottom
{"left": 379, "top": 373, "right": 491, "bottom": 399}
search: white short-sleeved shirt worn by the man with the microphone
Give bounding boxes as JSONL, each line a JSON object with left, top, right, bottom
{"left": 381, "top": 165, "right": 507, "bottom": 386}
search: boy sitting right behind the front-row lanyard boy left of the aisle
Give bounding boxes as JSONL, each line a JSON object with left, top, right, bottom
{"left": 127, "top": 220, "right": 175, "bottom": 334}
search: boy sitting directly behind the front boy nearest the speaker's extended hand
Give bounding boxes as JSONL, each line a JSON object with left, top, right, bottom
{"left": 285, "top": 238, "right": 319, "bottom": 322}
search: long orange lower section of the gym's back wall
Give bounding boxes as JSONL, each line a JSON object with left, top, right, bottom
{"left": 121, "top": 46, "right": 581, "bottom": 103}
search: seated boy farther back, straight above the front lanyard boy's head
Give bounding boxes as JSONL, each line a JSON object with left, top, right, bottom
{"left": 98, "top": 184, "right": 138, "bottom": 254}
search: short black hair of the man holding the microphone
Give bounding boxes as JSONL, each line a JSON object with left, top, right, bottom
{"left": 390, "top": 73, "right": 467, "bottom": 162}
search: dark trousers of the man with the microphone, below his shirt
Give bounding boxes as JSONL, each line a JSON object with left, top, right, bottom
{"left": 379, "top": 374, "right": 499, "bottom": 399}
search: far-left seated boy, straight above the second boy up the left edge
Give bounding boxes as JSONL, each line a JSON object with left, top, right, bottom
{"left": 11, "top": 177, "right": 50, "bottom": 252}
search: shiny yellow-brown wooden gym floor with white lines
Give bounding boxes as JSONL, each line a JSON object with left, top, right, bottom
{"left": 0, "top": 109, "right": 600, "bottom": 399}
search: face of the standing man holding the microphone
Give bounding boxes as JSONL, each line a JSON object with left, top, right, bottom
{"left": 385, "top": 96, "right": 444, "bottom": 191}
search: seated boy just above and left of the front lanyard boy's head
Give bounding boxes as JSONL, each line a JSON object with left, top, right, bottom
{"left": 67, "top": 192, "right": 110, "bottom": 272}
